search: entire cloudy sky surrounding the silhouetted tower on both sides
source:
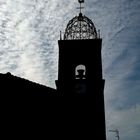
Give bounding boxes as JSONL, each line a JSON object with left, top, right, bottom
{"left": 0, "top": 0, "right": 140, "bottom": 140}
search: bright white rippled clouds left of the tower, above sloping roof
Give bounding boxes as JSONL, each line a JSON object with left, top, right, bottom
{"left": 0, "top": 0, "right": 74, "bottom": 87}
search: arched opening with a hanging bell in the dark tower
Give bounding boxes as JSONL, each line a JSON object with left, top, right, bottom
{"left": 75, "top": 65, "right": 86, "bottom": 79}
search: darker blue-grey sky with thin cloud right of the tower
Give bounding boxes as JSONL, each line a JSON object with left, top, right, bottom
{"left": 86, "top": 0, "right": 140, "bottom": 140}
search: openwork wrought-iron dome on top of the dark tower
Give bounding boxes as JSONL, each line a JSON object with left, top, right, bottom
{"left": 64, "top": 13, "right": 98, "bottom": 40}
